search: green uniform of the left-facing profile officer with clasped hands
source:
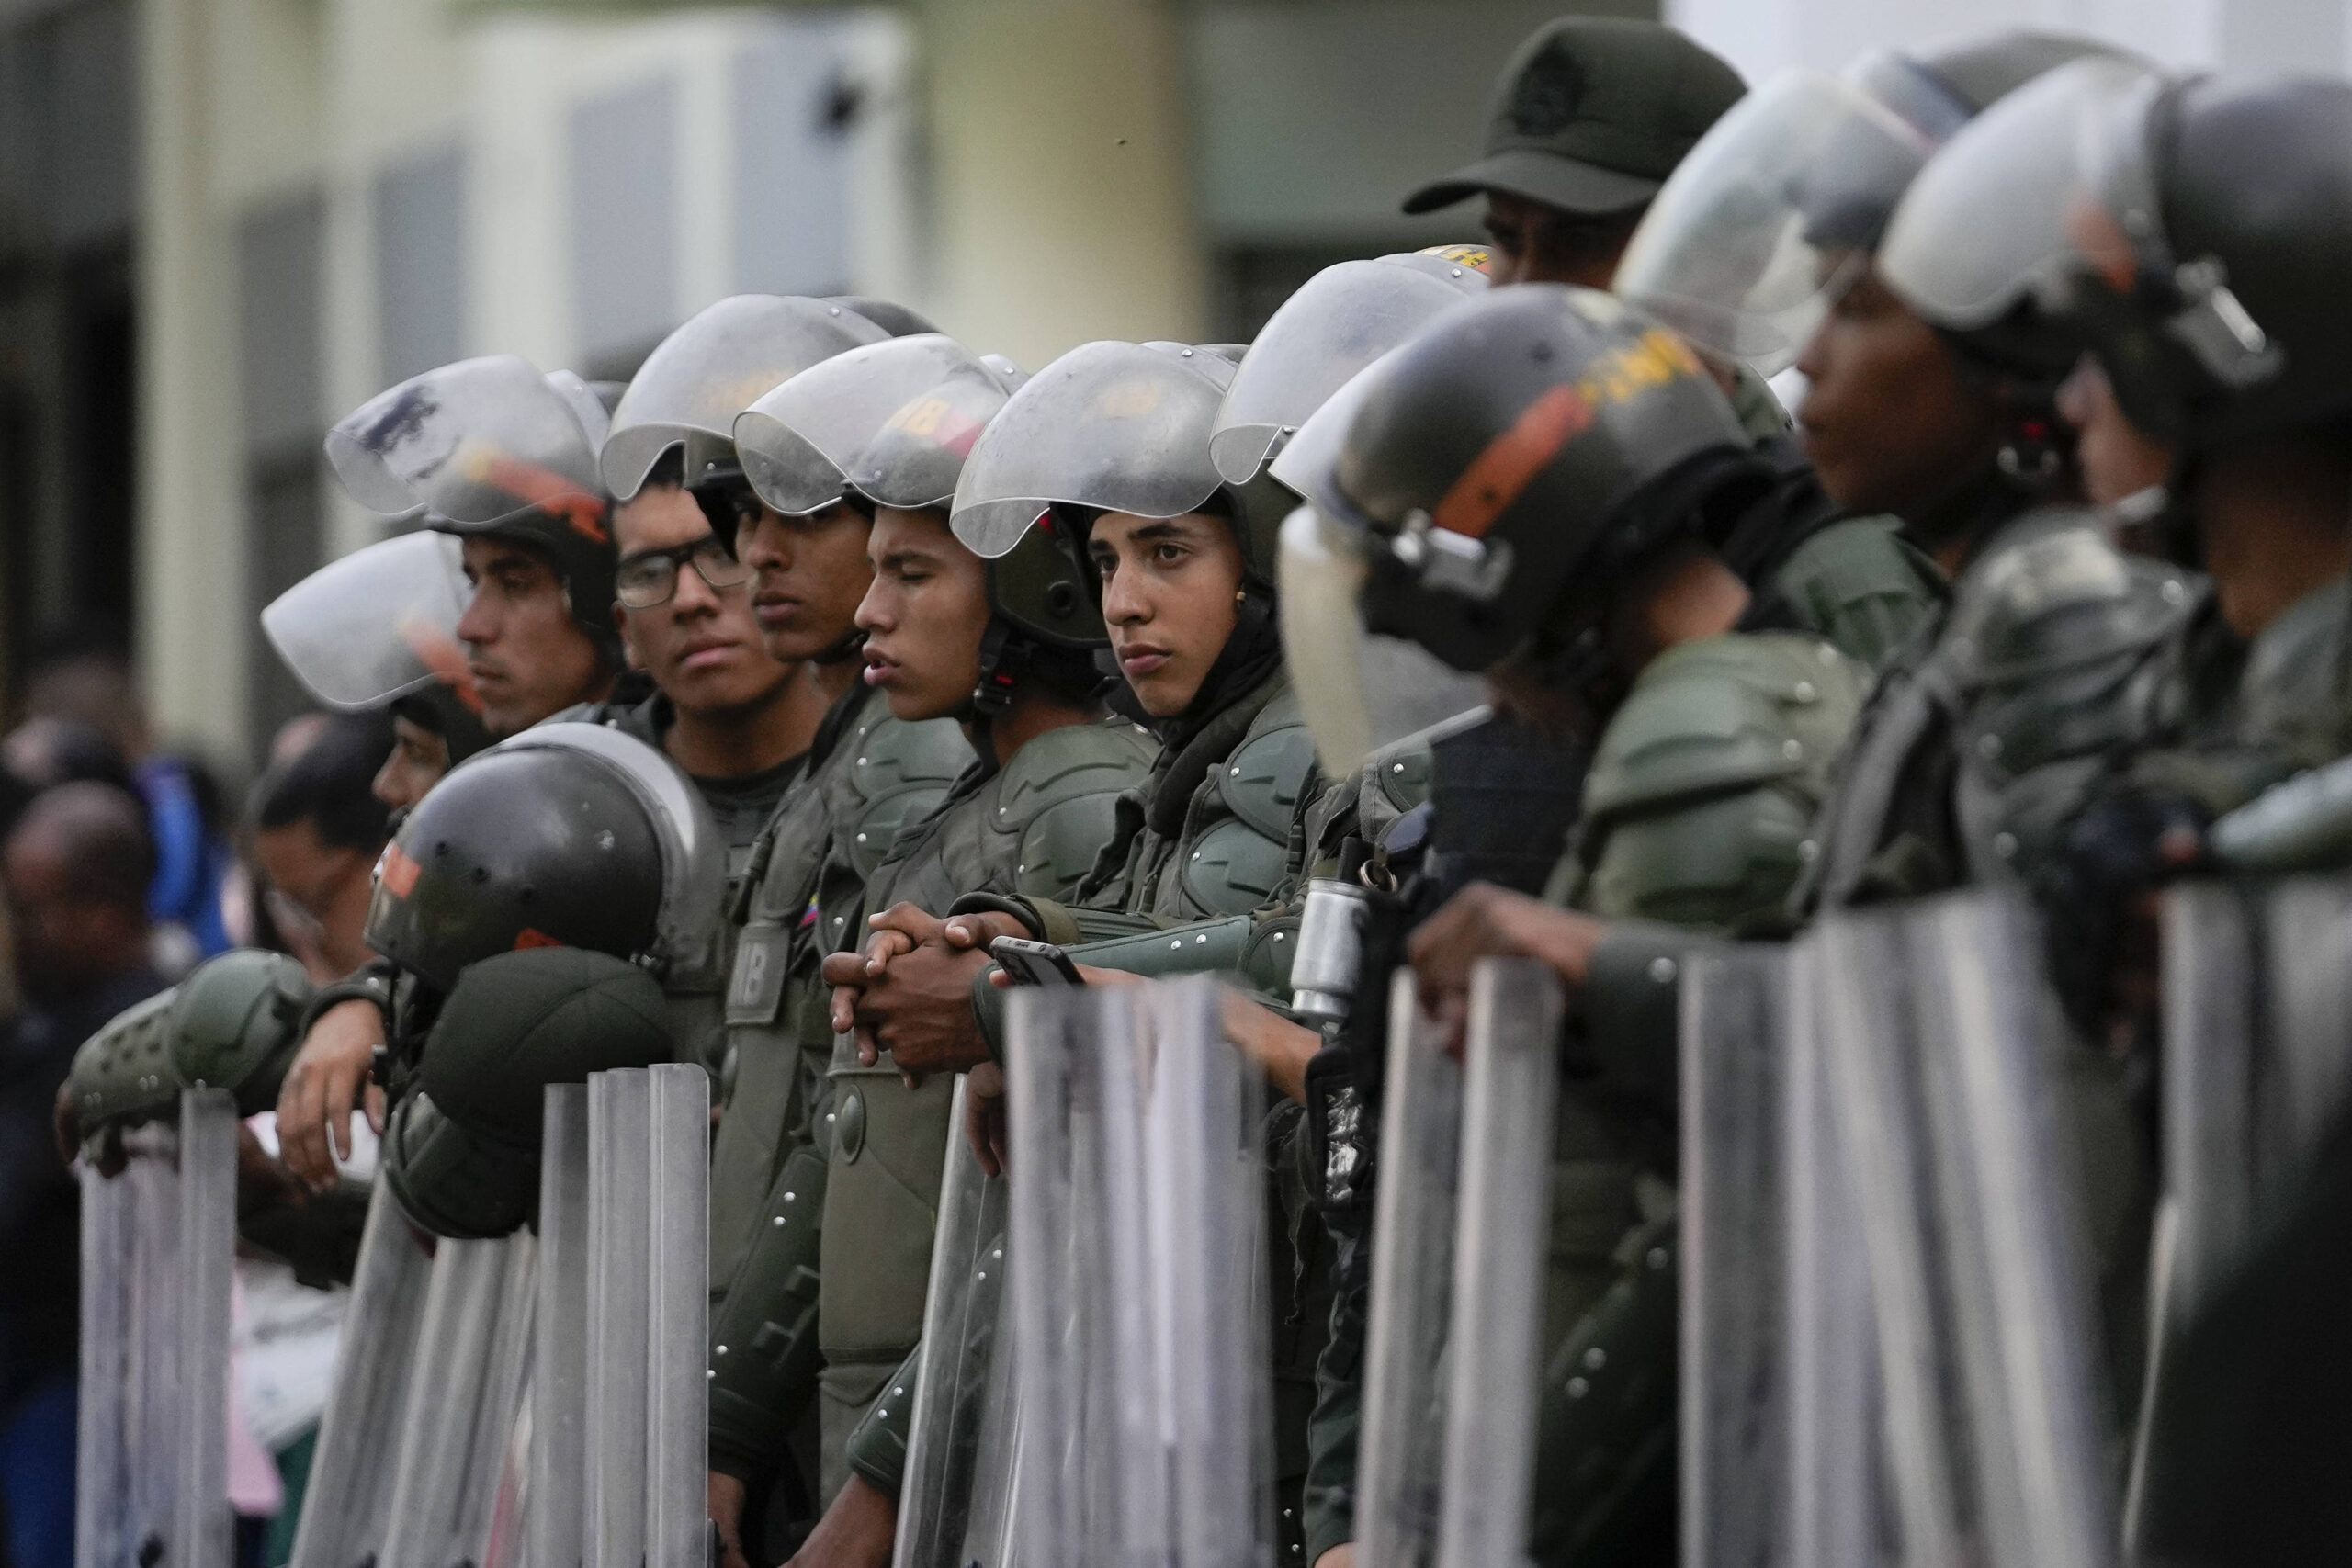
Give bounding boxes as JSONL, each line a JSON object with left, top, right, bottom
{"left": 807, "top": 719, "right": 1158, "bottom": 1497}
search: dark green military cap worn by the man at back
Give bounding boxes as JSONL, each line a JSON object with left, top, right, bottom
{"left": 1404, "top": 17, "right": 1747, "bottom": 216}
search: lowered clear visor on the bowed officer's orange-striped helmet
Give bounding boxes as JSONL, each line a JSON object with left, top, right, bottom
{"left": 1277, "top": 505, "right": 1484, "bottom": 778}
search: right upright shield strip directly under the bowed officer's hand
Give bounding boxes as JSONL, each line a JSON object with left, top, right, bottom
{"left": 1437, "top": 959, "right": 1562, "bottom": 1568}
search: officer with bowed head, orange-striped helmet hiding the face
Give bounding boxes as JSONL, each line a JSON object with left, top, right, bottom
{"left": 1284, "top": 287, "right": 1868, "bottom": 1561}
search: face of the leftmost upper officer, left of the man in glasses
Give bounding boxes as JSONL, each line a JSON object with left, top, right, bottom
{"left": 457, "top": 538, "right": 612, "bottom": 740}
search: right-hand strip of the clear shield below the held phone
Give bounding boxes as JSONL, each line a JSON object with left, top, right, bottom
{"left": 1138, "top": 976, "right": 1275, "bottom": 1565}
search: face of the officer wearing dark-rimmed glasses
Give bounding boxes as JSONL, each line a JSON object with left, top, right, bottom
{"left": 612, "top": 484, "right": 793, "bottom": 717}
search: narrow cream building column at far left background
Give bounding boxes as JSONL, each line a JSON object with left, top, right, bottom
{"left": 135, "top": 0, "right": 249, "bottom": 764}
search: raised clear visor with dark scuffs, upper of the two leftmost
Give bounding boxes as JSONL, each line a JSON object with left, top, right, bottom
{"left": 327, "top": 355, "right": 605, "bottom": 525}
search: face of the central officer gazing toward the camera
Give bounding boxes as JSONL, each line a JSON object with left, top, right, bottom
{"left": 1087, "top": 513, "right": 1242, "bottom": 719}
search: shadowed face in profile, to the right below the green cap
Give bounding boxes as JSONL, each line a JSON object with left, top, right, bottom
{"left": 1797, "top": 270, "right": 1999, "bottom": 522}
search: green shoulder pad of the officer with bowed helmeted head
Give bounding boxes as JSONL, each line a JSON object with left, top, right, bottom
{"left": 1585, "top": 632, "right": 1868, "bottom": 825}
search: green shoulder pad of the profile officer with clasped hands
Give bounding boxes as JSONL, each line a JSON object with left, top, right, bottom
{"left": 990, "top": 719, "right": 1159, "bottom": 898}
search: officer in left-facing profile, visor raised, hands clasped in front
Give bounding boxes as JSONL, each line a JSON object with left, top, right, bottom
{"left": 713, "top": 336, "right": 1155, "bottom": 1561}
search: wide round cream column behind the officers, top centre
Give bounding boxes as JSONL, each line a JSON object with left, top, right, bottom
{"left": 920, "top": 0, "right": 1204, "bottom": 369}
